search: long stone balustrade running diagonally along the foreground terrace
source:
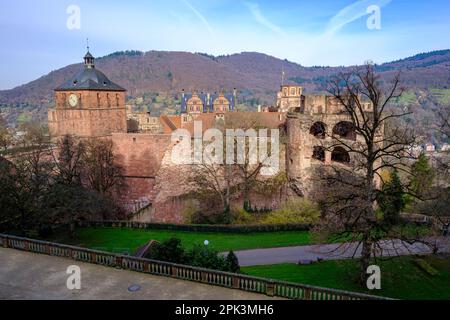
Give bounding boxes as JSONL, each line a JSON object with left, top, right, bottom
{"left": 0, "top": 234, "right": 388, "bottom": 300}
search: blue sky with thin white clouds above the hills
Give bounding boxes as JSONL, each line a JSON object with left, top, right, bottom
{"left": 0, "top": 0, "right": 450, "bottom": 90}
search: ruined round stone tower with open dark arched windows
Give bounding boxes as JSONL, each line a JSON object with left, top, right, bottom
{"left": 286, "top": 95, "right": 372, "bottom": 196}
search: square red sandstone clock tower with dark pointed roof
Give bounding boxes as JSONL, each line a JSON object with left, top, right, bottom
{"left": 48, "top": 47, "right": 127, "bottom": 138}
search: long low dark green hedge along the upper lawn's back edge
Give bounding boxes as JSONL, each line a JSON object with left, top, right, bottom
{"left": 77, "top": 221, "right": 311, "bottom": 233}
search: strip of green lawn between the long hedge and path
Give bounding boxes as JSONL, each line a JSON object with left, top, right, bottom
{"left": 50, "top": 228, "right": 310, "bottom": 254}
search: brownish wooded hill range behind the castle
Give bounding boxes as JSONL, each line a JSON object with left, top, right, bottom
{"left": 0, "top": 50, "right": 450, "bottom": 132}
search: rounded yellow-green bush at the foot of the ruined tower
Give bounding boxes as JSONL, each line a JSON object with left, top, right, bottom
{"left": 261, "top": 198, "right": 320, "bottom": 224}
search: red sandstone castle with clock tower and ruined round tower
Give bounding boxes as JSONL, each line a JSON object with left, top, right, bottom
{"left": 48, "top": 51, "right": 371, "bottom": 223}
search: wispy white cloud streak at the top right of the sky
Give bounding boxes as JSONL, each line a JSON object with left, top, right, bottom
{"left": 325, "top": 0, "right": 392, "bottom": 35}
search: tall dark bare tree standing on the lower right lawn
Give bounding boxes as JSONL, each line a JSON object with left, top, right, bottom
{"left": 314, "top": 64, "right": 428, "bottom": 283}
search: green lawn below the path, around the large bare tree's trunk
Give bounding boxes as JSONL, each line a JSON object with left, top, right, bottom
{"left": 241, "top": 255, "right": 450, "bottom": 300}
